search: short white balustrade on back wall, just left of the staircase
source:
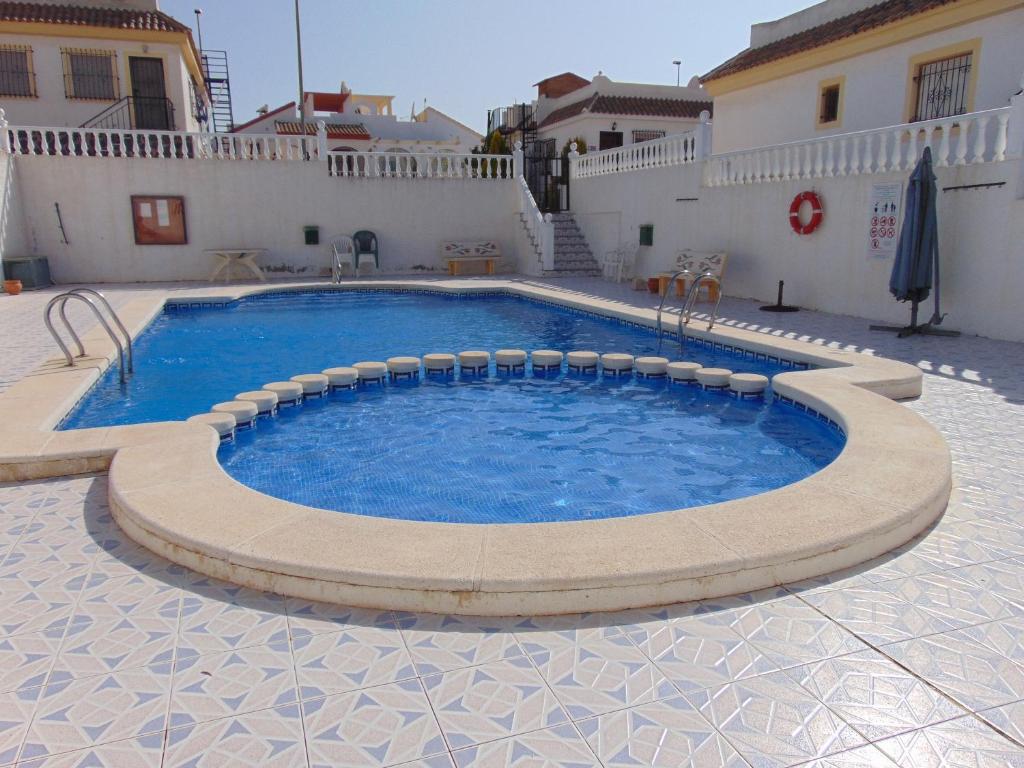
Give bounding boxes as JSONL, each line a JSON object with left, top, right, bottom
{"left": 327, "top": 152, "right": 513, "bottom": 179}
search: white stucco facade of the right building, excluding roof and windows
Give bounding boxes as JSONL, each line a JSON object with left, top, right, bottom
{"left": 713, "top": 8, "right": 1024, "bottom": 153}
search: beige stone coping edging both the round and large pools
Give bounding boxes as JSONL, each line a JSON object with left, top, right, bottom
{"left": 0, "top": 280, "right": 951, "bottom": 615}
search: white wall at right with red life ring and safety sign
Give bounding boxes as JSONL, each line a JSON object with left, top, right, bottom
{"left": 571, "top": 161, "right": 1024, "bottom": 341}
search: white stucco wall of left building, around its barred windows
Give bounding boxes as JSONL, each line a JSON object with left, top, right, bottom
{"left": 0, "top": 34, "right": 198, "bottom": 131}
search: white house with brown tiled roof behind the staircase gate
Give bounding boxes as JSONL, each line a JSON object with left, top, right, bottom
{"left": 536, "top": 73, "right": 712, "bottom": 152}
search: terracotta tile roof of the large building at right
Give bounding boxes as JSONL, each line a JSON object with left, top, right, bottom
{"left": 700, "top": 0, "right": 955, "bottom": 83}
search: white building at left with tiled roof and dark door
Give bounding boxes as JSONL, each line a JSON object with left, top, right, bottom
{"left": 0, "top": 0, "right": 209, "bottom": 131}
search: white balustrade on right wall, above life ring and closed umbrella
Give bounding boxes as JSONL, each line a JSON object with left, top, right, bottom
{"left": 703, "top": 106, "right": 1011, "bottom": 186}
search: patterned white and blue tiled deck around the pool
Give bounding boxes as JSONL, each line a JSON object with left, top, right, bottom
{"left": 0, "top": 280, "right": 1024, "bottom": 768}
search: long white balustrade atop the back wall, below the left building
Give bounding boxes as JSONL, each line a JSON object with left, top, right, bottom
{"left": 2, "top": 126, "right": 321, "bottom": 161}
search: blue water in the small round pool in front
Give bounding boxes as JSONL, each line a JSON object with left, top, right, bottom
{"left": 219, "top": 375, "right": 843, "bottom": 523}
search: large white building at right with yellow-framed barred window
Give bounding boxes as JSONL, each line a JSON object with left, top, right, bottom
{"left": 701, "top": 0, "right": 1024, "bottom": 153}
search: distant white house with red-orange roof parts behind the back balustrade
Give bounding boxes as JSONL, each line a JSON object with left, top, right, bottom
{"left": 234, "top": 83, "right": 483, "bottom": 153}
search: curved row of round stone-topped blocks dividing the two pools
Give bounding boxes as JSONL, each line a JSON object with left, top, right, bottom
{"left": 187, "top": 349, "right": 769, "bottom": 440}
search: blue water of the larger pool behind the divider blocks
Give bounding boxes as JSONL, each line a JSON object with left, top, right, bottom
{"left": 61, "top": 291, "right": 782, "bottom": 429}
